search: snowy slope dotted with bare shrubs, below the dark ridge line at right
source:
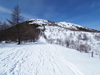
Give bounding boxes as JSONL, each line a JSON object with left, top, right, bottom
{"left": 44, "top": 26, "right": 100, "bottom": 55}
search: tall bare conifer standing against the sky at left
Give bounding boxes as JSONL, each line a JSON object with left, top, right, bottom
{"left": 7, "top": 5, "right": 23, "bottom": 44}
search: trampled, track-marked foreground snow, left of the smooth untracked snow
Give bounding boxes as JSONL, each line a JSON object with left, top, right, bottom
{"left": 0, "top": 44, "right": 84, "bottom": 75}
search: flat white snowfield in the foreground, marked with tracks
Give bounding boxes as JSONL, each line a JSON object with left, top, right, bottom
{"left": 0, "top": 42, "right": 100, "bottom": 75}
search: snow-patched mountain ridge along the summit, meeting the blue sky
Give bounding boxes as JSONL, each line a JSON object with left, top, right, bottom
{"left": 28, "top": 19, "right": 100, "bottom": 32}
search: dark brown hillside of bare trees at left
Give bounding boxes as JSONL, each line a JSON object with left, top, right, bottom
{"left": 0, "top": 21, "right": 40, "bottom": 43}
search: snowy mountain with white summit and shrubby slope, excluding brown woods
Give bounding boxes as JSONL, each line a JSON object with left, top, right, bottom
{"left": 29, "top": 19, "right": 100, "bottom": 54}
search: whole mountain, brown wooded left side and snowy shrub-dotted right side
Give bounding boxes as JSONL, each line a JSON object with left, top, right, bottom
{"left": 0, "top": 19, "right": 100, "bottom": 55}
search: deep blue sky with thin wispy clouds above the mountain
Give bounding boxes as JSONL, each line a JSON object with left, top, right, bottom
{"left": 0, "top": 0, "right": 100, "bottom": 30}
